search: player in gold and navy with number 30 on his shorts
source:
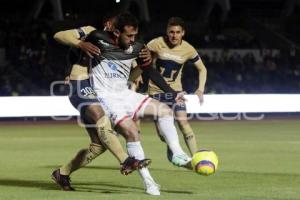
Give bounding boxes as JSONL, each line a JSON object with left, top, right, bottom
{"left": 51, "top": 13, "right": 151, "bottom": 191}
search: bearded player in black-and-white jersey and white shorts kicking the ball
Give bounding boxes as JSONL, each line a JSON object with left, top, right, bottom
{"left": 86, "top": 13, "right": 190, "bottom": 195}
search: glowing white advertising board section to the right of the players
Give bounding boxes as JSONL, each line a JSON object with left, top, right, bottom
{"left": 186, "top": 94, "right": 300, "bottom": 113}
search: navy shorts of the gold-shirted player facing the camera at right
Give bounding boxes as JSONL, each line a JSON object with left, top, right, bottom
{"left": 150, "top": 93, "right": 186, "bottom": 112}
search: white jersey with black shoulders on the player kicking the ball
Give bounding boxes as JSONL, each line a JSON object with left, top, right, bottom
{"left": 86, "top": 31, "right": 143, "bottom": 93}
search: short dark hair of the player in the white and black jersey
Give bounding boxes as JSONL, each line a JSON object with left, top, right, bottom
{"left": 114, "top": 12, "right": 139, "bottom": 32}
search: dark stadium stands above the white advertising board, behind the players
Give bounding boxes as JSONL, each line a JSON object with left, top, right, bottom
{"left": 0, "top": 0, "right": 300, "bottom": 96}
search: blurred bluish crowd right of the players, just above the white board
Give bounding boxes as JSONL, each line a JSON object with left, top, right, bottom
{"left": 182, "top": 49, "right": 300, "bottom": 94}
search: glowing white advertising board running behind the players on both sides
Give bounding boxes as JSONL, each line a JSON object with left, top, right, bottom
{"left": 0, "top": 94, "right": 300, "bottom": 117}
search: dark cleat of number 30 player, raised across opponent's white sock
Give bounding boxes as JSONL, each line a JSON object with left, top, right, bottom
{"left": 120, "top": 157, "right": 151, "bottom": 176}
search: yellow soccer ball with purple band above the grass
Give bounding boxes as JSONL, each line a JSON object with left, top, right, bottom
{"left": 191, "top": 149, "right": 219, "bottom": 176}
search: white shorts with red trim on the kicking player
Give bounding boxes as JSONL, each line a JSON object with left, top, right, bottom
{"left": 97, "top": 89, "right": 151, "bottom": 126}
